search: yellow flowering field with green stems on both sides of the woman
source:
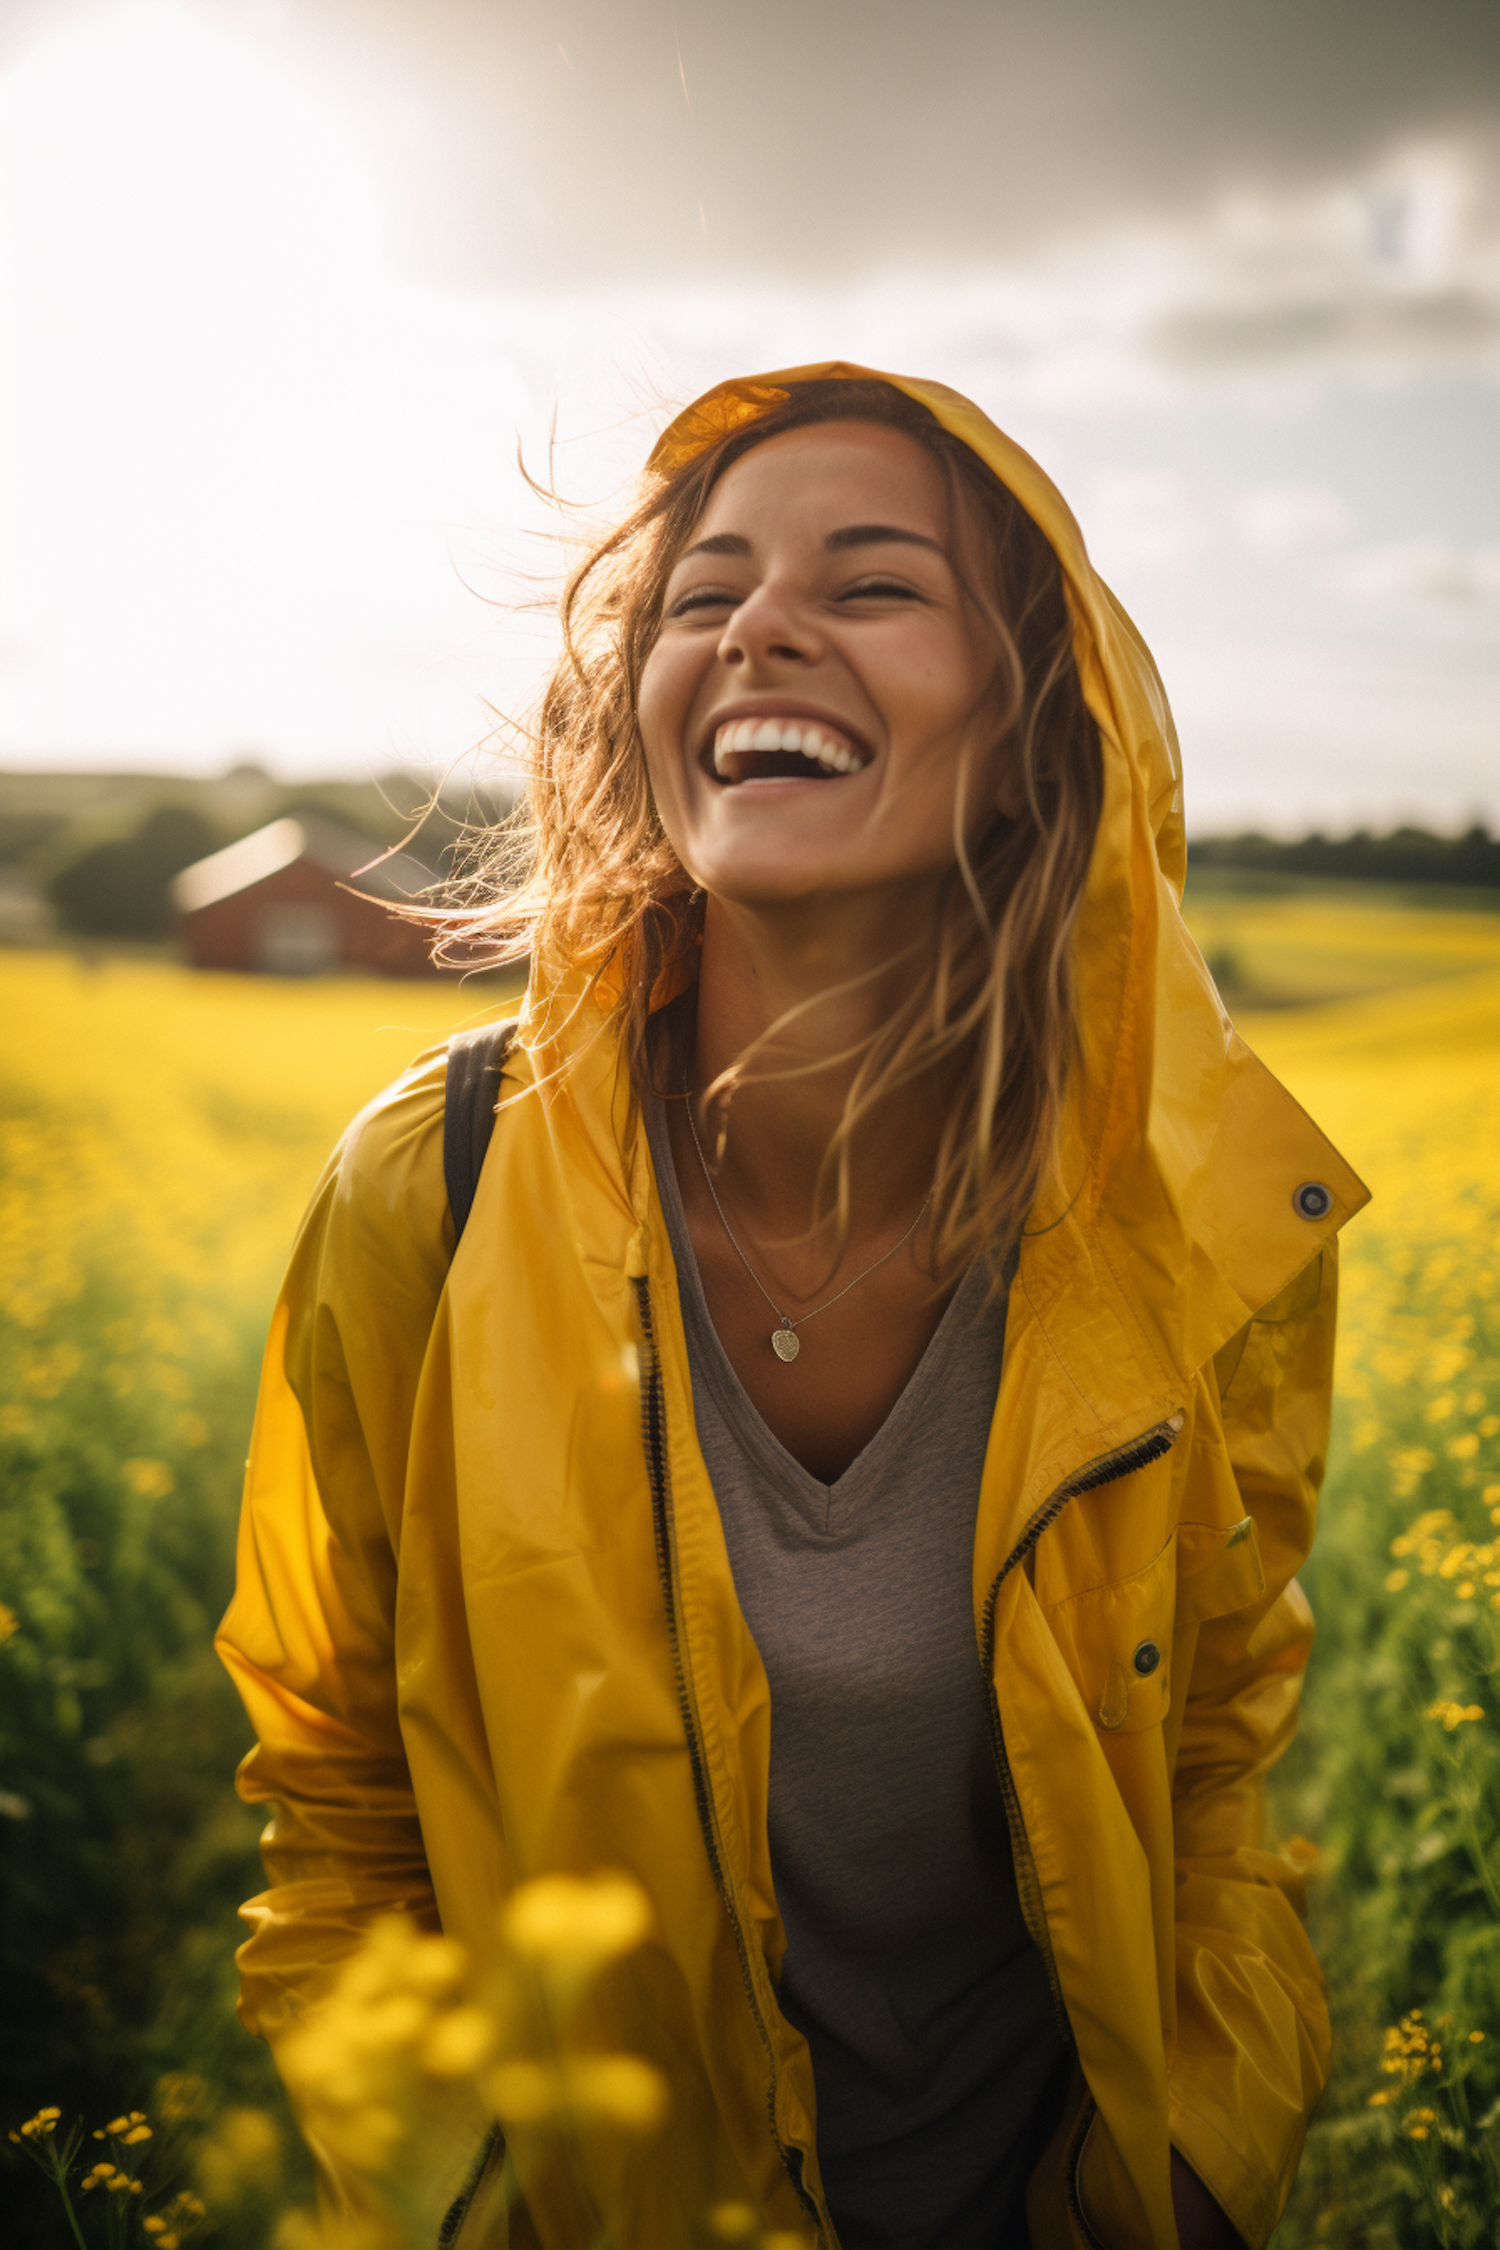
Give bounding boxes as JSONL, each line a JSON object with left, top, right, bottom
{"left": 0, "top": 893, "right": 1500, "bottom": 2250}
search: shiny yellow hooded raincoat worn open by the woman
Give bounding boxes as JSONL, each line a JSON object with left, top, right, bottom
{"left": 220, "top": 365, "right": 1365, "bottom": 2250}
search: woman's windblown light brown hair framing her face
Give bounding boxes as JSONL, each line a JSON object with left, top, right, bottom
{"left": 443, "top": 378, "right": 1102, "bottom": 1280}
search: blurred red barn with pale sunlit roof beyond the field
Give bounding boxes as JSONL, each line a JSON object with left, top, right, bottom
{"left": 171, "top": 817, "right": 436, "bottom": 977}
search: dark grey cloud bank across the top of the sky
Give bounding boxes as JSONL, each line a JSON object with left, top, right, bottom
{"left": 17, "top": 0, "right": 1500, "bottom": 294}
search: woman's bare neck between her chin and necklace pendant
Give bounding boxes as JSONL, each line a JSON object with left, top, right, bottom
{"left": 690, "top": 896, "right": 942, "bottom": 1247}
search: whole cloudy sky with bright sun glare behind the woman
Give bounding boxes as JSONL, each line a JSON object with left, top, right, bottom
{"left": 0, "top": 0, "right": 1500, "bottom": 828}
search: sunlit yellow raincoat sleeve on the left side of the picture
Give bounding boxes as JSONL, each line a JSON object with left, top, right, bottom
{"left": 218, "top": 1051, "right": 454, "bottom": 2043}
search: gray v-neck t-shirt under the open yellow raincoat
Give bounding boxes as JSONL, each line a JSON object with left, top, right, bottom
{"left": 645, "top": 1103, "right": 1064, "bottom": 2250}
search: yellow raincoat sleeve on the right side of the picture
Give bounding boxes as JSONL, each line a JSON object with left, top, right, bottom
{"left": 1172, "top": 1244, "right": 1336, "bottom": 2250}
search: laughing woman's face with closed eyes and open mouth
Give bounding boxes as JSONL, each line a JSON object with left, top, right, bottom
{"left": 641, "top": 423, "right": 1014, "bottom": 907}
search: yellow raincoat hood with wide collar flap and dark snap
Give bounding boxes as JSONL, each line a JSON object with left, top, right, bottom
{"left": 629, "top": 360, "right": 1370, "bottom": 1379}
